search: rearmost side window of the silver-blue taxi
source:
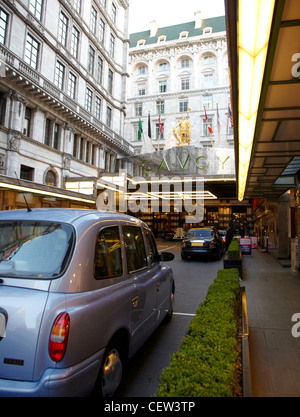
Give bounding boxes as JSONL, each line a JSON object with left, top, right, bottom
{"left": 94, "top": 226, "right": 123, "bottom": 279}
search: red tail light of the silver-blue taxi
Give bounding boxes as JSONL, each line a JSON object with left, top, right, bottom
{"left": 49, "top": 313, "right": 70, "bottom": 362}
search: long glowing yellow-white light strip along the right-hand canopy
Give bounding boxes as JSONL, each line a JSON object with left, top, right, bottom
{"left": 237, "top": 0, "right": 275, "bottom": 201}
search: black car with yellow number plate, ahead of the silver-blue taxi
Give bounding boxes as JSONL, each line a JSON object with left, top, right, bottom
{"left": 181, "top": 227, "right": 223, "bottom": 260}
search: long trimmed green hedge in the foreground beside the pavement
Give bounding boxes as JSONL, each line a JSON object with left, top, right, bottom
{"left": 156, "top": 269, "right": 241, "bottom": 397}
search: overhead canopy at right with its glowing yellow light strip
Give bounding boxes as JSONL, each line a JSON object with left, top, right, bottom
{"left": 225, "top": 0, "right": 300, "bottom": 200}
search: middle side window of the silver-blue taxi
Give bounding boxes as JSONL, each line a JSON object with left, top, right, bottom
{"left": 123, "top": 226, "right": 147, "bottom": 273}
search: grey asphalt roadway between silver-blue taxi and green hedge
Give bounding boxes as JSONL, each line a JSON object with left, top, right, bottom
{"left": 116, "top": 239, "right": 223, "bottom": 397}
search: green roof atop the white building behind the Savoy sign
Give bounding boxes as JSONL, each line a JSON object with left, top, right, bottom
{"left": 130, "top": 16, "right": 226, "bottom": 48}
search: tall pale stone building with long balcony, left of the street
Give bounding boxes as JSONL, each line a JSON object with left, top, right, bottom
{"left": 0, "top": 0, "right": 133, "bottom": 209}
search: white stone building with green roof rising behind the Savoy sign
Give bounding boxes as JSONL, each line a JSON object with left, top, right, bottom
{"left": 125, "top": 12, "right": 233, "bottom": 153}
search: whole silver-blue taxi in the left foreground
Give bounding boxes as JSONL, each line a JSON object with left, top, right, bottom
{"left": 0, "top": 209, "right": 175, "bottom": 397}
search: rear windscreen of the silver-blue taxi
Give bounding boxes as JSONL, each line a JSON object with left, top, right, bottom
{"left": 0, "top": 221, "right": 74, "bottom": 279}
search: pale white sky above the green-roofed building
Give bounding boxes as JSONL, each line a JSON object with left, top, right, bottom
{"left": 129, "top": 0, "right": 225, "bottom": 33}
